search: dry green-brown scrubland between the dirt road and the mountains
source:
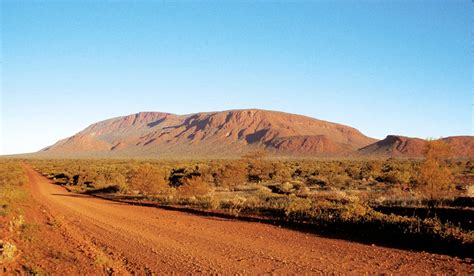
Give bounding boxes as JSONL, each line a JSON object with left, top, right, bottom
{"left": 27, "top": 155, "right": 474, "bottom": 257}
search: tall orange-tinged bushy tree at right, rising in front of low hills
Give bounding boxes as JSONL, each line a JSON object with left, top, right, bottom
{"left": 417, "top": 140, "right": 453, "bottom": 207}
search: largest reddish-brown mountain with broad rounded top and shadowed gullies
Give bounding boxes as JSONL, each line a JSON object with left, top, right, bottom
{"left": 41, "top": 109, "right": 377, "bottom": 157}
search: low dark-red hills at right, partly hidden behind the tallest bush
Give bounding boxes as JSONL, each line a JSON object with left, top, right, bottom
{"left": 358, "top": 135, "right": 474, "bottom": 157}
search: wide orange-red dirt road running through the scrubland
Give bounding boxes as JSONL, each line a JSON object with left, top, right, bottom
{"left": 26, "top": 164, "right": 474, "bottom": 274}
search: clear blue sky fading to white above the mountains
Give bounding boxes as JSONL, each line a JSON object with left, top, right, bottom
{"left": 0, "top": 0, "right": 473, "bottom": 154}
